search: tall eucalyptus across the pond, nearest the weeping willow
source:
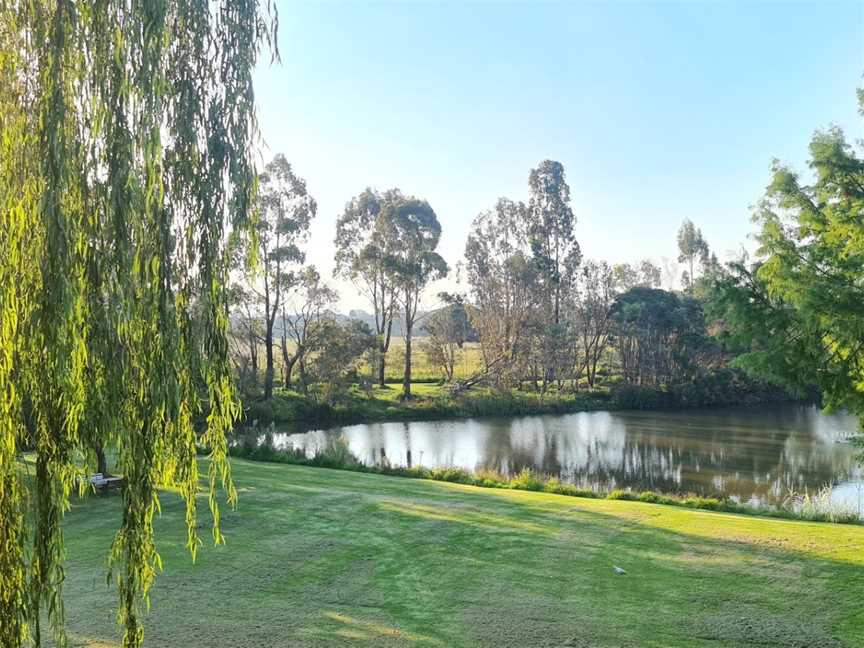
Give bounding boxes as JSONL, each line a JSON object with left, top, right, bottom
{"left": 248, "top": 154, "right": 318, "bottom": 398}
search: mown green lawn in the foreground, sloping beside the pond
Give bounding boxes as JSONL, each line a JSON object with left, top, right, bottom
{"left": 59, "top": 460, "right": 864, "bottom": 648}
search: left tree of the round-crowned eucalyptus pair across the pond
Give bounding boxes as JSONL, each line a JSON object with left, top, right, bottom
{"left": 333, "top": 189, "right": 405, "bottom": 387}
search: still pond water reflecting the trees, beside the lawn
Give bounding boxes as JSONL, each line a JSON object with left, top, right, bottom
{"left": 245, "top": 404, "right": 864, "bottom": 508}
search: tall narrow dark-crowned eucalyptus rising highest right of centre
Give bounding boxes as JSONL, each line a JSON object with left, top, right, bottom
{"left": 527, "top": 160, "right": 581, "bottom": 324}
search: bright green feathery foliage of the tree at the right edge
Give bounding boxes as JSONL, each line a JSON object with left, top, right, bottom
{"left": 710, "top": 91, "right": 864, "bottom": 420}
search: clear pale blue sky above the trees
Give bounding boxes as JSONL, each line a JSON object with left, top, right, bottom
{"left": 256, "top": 2, "right": 864, "bottom": 309}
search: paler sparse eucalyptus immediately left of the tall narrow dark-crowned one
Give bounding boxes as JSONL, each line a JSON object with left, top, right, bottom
{"left": 465, "top": 198, "right": 540, "bottom": 378}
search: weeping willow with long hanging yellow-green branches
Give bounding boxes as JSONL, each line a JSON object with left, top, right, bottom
{"left": 0, "top": 0, "right": 276, "bottom": 646}
